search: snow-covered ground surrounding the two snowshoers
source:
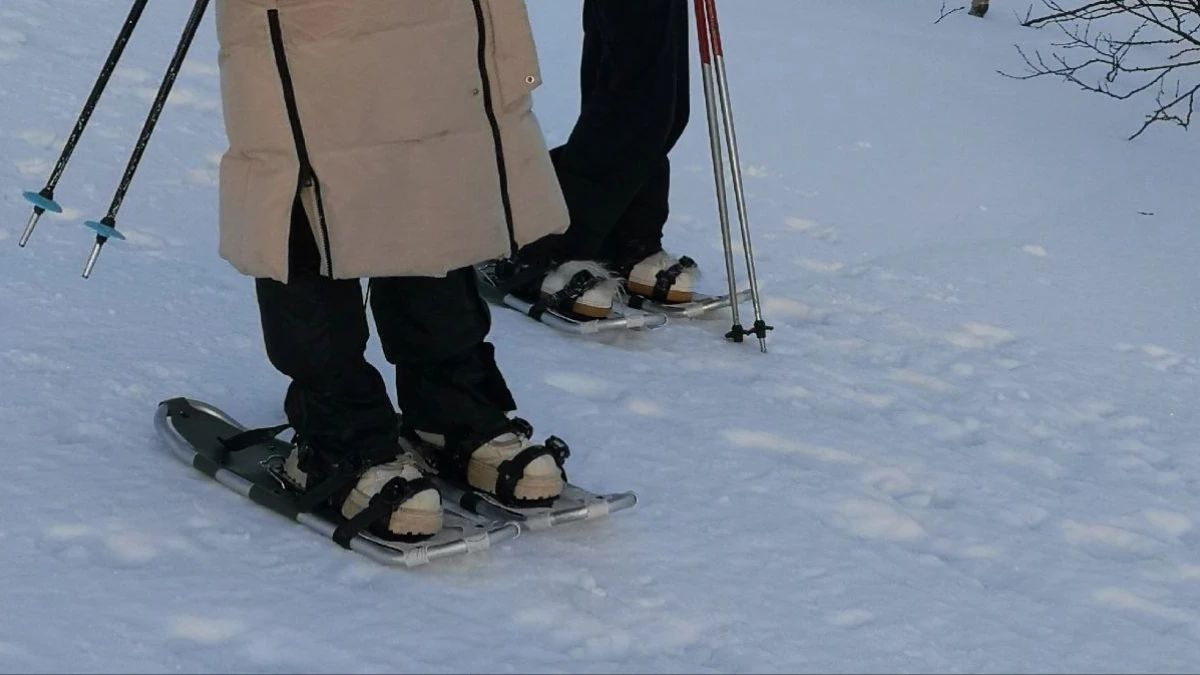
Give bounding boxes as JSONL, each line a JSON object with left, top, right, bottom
{"left": 0, "top": 0, "right": 1200, "bottom": 673}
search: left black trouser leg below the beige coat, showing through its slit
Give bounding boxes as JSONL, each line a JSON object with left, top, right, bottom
{"left": 256, "top": 194, "right": 396, "bottom": 458}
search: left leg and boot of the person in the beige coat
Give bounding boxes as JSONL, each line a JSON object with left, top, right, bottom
{"left": 256, "top": 193, "right": 442, "bottom": 537}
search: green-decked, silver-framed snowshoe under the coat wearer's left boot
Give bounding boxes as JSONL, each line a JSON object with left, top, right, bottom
{"left": 155, "top": 398, "right": 521, "bottom": 567}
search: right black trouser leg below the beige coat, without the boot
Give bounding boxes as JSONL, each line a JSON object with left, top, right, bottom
{"left": 371, "top": 267, "right": 516, "bottom": 436}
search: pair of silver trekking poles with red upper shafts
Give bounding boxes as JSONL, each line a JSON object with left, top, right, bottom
{"left": 695, "top": 0, "right": 773, "bottom": 352}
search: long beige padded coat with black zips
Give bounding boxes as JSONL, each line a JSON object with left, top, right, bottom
{"left": 216, "top": 0, "right": 568, "bottom": 281}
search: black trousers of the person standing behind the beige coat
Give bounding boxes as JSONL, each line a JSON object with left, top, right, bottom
{"left": 536, "top": 0, "right": 691, "bottom": 263}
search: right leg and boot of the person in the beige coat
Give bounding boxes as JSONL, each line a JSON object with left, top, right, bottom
{"left": 371, "top": 268, "right": 565, "bottom": 503}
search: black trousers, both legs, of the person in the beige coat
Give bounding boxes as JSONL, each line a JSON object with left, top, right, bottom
{"left": 256, "top": 194, "right": 516, "bottom": 458}
